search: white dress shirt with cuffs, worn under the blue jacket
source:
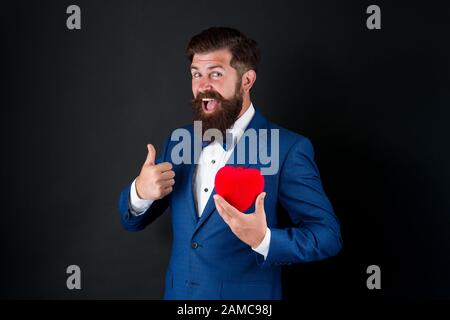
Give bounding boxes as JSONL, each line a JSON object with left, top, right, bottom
{"left": 130, "top": 104, "right": 271, "bottom": 259}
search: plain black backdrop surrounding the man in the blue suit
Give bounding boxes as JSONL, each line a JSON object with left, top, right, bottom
{"left": 0, "top": 0, "right": 450, "bottom": 300}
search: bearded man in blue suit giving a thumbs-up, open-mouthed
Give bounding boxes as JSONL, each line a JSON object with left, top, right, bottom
{"left": 119, "top": 27, "right": 342, "bottom": 300}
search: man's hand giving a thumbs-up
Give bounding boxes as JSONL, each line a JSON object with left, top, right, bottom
{"left": 136, "top": 144, "right": 175, "bottom": 200}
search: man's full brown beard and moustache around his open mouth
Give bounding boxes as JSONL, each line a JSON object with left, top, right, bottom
{"left": 192, "top": 82, "right": 244, "bottom": 137}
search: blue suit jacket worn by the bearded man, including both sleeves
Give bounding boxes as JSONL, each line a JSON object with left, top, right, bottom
{"left": 119, "top": 111, "right": 341, "bottom": 299}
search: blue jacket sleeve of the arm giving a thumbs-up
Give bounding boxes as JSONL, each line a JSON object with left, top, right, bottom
{"left": 119, "top": 134, "right": 171, "bottom": 231}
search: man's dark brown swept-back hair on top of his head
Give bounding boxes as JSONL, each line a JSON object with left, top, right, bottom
{"left": 186, "top": 27, "right": 261, "bottom": 74}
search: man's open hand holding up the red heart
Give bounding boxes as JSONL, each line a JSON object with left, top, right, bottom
{"left": 214, "top": 192, "right": 267, "bottom": 248}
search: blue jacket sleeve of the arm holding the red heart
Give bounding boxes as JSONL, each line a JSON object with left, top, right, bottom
{"left": 258, "top": 137, "right": 342, "bottom": 266}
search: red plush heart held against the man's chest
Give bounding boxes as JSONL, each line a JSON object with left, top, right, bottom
{"left": 214, "top": 166, "right": 264, "bottom": 212}
